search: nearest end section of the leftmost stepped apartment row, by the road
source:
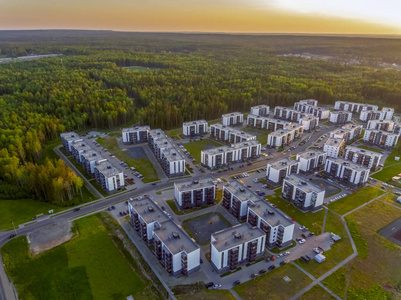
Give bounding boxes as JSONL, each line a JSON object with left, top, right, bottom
{"left": 94, "top": 159, "right": 124, "bottom": 193}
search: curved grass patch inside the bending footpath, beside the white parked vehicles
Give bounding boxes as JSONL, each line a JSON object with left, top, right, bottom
{"left": 296, "top": 211, "right": 353, "bottom": 278}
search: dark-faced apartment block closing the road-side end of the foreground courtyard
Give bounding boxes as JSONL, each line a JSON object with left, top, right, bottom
{"left": 174, "top": 177, "right": 216, "bottom": 209}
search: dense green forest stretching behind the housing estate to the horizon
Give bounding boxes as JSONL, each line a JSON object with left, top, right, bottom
{"left": 0, "top": 31, "right": 401, "bottom": 205}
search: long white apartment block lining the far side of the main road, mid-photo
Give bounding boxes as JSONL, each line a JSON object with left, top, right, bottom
{"left": 201, "top": 140, "right": 262, "bottom": 169}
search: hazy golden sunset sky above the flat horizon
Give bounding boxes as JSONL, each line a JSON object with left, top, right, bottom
{"left": 0, "top": 0, "right": 401, "bottom": 34}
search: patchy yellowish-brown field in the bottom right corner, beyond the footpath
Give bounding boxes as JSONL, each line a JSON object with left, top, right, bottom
{"left": 323, "top": 201, "right": 401, "bottom": 299}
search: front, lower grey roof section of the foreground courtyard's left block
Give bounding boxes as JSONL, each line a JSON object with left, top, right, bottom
{"left": 154, "top": 220, "right": 199, "bottom": 254}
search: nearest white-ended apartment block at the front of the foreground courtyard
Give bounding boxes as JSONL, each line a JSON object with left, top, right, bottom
{"left": 210, "top": 223, "right": 266, "bottom": 273}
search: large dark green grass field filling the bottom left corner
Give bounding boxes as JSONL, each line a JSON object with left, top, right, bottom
{"left": 1, "top": 214, "right": 166, "bottom": 299}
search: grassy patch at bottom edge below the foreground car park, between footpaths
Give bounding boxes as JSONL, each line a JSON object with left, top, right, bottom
{"left": 234, "top": 264, "right": 312, "bottom": 300}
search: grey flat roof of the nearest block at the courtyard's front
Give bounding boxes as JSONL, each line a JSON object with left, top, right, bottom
{"left": 212, "top": 223, "right": 266, "bottom": 252}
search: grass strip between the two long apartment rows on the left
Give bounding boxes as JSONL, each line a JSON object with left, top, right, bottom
{"left": 97, "top": 136, "right": 159, "bottom": 183}
